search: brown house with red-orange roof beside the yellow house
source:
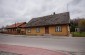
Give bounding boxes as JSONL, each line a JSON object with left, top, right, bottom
{"left": 6, "top": 22, "right": 26, "bottom": 34}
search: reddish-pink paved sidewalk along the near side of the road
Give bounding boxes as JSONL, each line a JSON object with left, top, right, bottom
{"left": 0, "top": 44, "right": 70, "bottom": 55}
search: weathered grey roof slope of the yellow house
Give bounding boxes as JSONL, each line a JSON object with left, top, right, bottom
{"left": 27, "top": 12, "right": 70, "bottom": 27}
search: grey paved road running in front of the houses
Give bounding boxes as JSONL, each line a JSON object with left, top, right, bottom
{"left": 0, "top": 34, "right": 85, "bottom": 54}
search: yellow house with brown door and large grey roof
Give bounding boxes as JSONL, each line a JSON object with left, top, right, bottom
{"left": 26, "top": 12, "right": 70, "bottom": 36}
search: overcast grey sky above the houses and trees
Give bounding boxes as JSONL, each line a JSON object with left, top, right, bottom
{"left": 0, "top": 0, "right": 85, "bottom": 27}
